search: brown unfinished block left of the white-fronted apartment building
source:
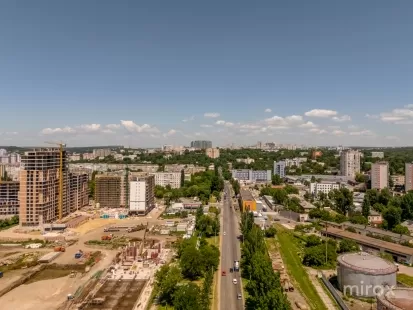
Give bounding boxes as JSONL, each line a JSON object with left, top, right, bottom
{"left": 95, "top": 174, "right": 122, "bottom": 208}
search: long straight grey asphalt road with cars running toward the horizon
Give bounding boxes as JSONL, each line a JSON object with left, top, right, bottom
{"left": 220, "top": 183, "right": 244, "bottom": 310}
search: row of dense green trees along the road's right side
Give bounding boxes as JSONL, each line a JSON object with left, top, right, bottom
{"left": 241, "top": 212, "right": 291, "bottom": 310}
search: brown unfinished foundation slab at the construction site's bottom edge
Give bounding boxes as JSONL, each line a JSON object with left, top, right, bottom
{"left": 83, "top": 280, "right": 146, "bottom": 310}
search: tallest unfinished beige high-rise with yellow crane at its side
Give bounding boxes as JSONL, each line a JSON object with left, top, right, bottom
{"left": 19, "top": 148, "right": 70, "bottom": 226}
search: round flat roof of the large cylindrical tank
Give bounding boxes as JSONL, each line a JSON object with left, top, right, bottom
{"left": 338, "top": 252, "right": 397, "bottom": 274}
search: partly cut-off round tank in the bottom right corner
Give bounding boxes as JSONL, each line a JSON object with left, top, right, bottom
{"left": 376, "top": 287, "right": 413, "bottom": 310}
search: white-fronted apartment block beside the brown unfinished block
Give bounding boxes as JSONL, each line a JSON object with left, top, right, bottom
{"left": 129, "top": 175, "right": 155, "bottom": 215}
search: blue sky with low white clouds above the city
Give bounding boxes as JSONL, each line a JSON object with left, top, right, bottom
{"left": 0, "top": 0, "right": 413, "bottom": 147}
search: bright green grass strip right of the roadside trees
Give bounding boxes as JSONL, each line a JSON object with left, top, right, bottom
{"left": 277, "top": 225, "right": 327, "bottom": 310}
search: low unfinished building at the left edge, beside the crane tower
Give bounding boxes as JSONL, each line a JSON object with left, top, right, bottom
{"left": 0, "top": 181, "right": 20, "bottom": 217}
